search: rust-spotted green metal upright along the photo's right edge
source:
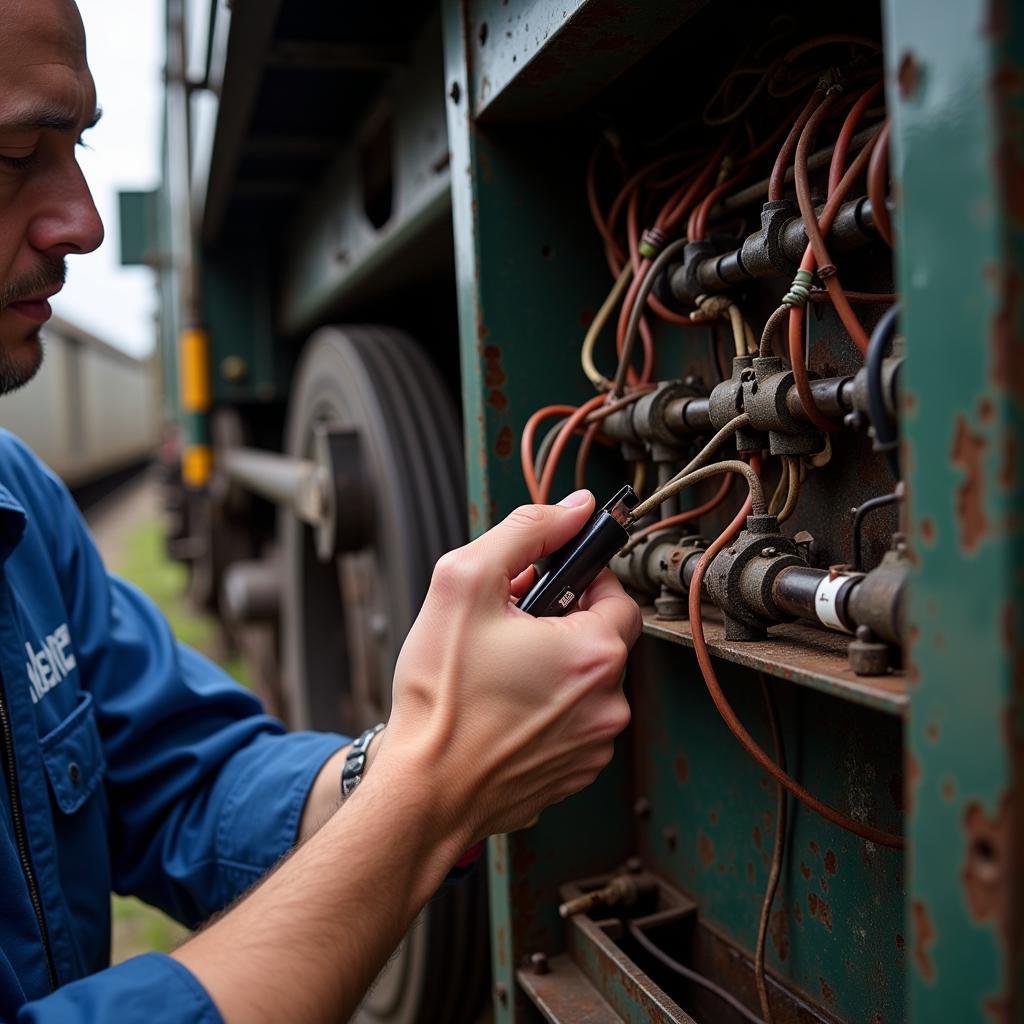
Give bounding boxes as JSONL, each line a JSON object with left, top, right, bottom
{"left": 886, "top": 0, "right": 1024, "bottom": 1022}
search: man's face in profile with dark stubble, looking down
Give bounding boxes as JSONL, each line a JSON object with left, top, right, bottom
{"left": 0, "top": 0, "right": 103, "bottom": 394}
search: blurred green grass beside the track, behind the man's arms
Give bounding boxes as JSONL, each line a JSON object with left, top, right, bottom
{"left": 110, "top": 518, "right": 249, "bottom": 964}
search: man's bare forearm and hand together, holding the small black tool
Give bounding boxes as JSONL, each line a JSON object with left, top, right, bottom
{"left": 174, "top": 493, "right": 640, "bottom": 1024}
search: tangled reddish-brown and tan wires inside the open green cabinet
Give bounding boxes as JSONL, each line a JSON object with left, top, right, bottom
{"left": 520, "top": 35, "right": 903, "bottom": 1022}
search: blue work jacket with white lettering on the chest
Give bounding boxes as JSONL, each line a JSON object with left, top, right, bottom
{"left": 0, "top": 431, "right": 346, "bottom": 1024}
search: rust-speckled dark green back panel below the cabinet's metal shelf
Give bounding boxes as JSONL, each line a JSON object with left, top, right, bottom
{"left": 630, "top": 638, "right": 908, "bottom": 1024}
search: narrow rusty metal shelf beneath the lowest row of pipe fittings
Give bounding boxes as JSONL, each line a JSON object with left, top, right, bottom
{"left": 642, "top": 605, "right": 909, "bottom": 715}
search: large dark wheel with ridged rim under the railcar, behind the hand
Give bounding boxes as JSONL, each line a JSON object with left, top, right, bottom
{"left": 281, "top": 327, "right": 487, "bottom": 1024}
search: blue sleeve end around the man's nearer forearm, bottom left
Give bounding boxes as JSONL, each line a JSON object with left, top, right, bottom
{"left": 16, "top": 953, "right": 223, "bottom": 1024}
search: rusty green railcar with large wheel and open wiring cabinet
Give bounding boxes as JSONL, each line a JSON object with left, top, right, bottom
{"left": 132, "top": 0, "right": 1024, "bottom": 1024}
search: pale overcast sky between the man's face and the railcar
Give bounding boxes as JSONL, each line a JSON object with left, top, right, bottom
{"left": 52, "top": 0, "right": 164, "bottom": 355}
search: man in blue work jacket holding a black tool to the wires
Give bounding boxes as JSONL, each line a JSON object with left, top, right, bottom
{"left": 0, "top": 0, "right": 639, "bottom": 1024}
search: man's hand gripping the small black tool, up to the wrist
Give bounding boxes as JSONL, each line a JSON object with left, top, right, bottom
{"left": 379, "top": 492, "right": 641, "bottom": 839}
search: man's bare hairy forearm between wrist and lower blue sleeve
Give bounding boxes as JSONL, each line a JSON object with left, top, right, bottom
{"left": 174, "top": 755, "right": 473, "bottom": 1024}
